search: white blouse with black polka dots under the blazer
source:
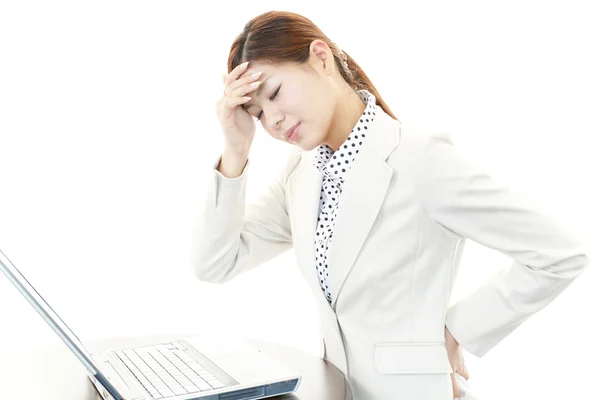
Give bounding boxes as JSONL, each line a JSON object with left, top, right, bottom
{"left": 314, "top": 90, "right": 376, "bottom": 305}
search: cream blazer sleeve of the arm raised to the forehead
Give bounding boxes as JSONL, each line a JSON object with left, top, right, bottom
{"left": 191, "top": 153, "right": 299, "bottom": 283}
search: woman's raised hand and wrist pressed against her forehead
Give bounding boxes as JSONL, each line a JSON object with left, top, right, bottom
{"left": 217, "top": 63, "right": 258, "bottom": 152}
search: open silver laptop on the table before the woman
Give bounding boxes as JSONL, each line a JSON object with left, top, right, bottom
{"left": 0, "top": 250, "right": 302, "bottom": 400}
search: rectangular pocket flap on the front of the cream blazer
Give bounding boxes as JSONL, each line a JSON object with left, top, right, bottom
{"left": 373, "top": 342, "right": 452, "bottom": 374}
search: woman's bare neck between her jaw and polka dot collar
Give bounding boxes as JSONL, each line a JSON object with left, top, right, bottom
{"left": 323, "top": 86, "right": 367, "bottom": 152}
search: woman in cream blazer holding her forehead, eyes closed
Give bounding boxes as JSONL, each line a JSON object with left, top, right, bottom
{"left": 193, "top": 12, "right": 587, "bottom": 400}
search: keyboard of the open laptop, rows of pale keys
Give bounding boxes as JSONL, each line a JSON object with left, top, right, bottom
{"left": 113, "top": 342, "right": 225, "bottom": 399}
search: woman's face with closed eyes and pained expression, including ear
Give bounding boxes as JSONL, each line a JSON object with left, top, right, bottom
{"left": 242, "top": 42, "right": 343, "bottom": 150}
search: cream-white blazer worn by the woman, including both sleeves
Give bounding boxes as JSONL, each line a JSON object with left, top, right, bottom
{"left": 191, "top": 106, "right": 588, "bottom": 400}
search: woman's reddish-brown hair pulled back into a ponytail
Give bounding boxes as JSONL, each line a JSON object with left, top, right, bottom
{"left": 227, "top": 11, "right": 397, "bottom": 120}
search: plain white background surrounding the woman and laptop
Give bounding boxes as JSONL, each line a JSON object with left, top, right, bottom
{"left": 0, "top": 0, "right": 600, "bottom": 400}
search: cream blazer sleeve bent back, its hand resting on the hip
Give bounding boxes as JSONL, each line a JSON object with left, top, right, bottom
{"left": 414, "top": 132, "right": 588, "bottom": 357}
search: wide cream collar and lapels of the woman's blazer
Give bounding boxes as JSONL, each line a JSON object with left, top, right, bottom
{"left": 288, "top": 105, "right": 400, "bottom": 311}
